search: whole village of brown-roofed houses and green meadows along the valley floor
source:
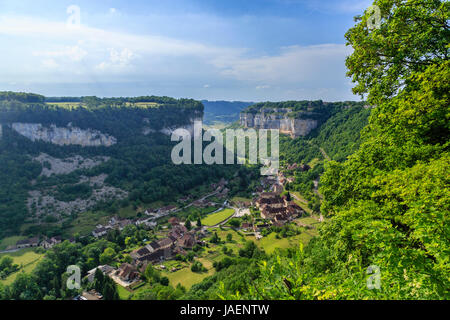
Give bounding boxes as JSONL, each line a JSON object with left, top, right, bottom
{"left": 1, "top": 164, "right": 322, "bottom": 300}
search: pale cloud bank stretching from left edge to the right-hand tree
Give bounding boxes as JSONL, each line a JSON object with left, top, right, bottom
{"left": 0, "top": 15, "right": 351, "bottom": 100}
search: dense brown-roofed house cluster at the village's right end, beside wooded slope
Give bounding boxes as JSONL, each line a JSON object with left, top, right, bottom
{"left": 255, "top": 192, "right": 304, "bottom": 226}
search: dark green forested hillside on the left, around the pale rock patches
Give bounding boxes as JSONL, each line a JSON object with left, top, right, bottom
{"left": 0, "top": 92, "right": 232, "bottom": 238}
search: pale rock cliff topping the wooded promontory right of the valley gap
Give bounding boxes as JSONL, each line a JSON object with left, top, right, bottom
{"left": 240, "top": 109, "right": 319, "bottom": 137}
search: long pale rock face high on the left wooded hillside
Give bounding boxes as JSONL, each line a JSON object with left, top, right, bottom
{"left": 12, "top": 122, "right": 117, "bottom": 147}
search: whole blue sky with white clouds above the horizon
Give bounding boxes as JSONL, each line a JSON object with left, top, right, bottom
{"left": 0, "top": 0, "right": 371, "bottom": 101}
